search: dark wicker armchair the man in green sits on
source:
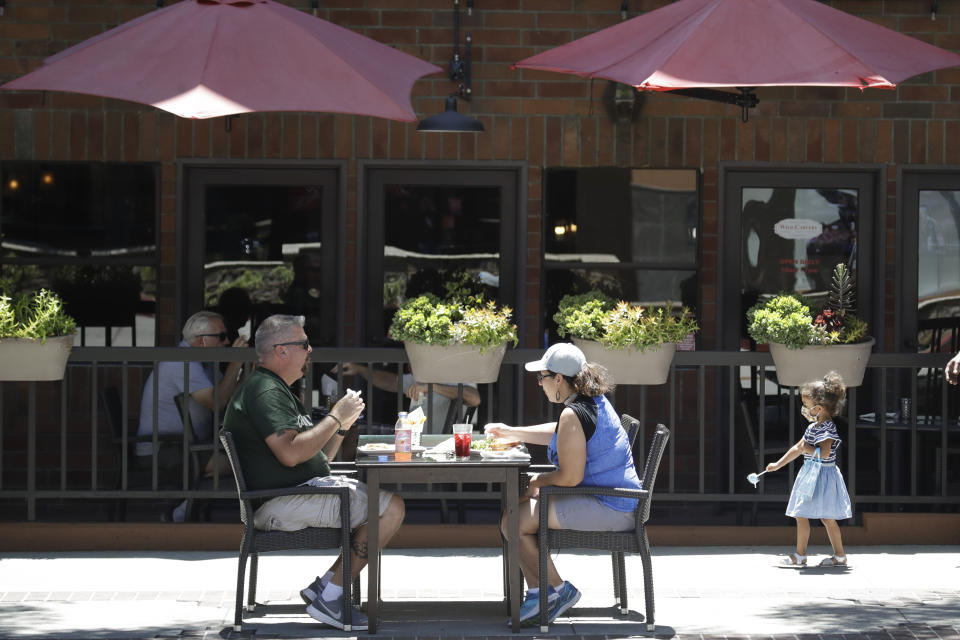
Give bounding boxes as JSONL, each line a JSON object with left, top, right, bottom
{"left": 220, "top": 429, "right": 360, "bottom": 631}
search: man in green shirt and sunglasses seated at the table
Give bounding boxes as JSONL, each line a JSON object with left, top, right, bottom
{"left": 223, "top": 315, "right": 404, "bottom": 631}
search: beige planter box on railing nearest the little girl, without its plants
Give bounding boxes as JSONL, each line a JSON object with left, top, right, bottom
{"left": 770, "top": 338, "right": 876, "bottom": 387}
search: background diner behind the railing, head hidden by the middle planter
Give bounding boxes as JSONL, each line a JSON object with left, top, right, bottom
{"left": 343, "top": 362, "right": 480, "bottom": 433}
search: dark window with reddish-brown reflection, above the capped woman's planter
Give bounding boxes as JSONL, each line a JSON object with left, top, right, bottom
{"left": 543, "top": 167, "right": 700, "bottom": 341}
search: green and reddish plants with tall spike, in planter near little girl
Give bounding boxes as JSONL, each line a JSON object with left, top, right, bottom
{"left": 747, "top": 263, "right": 867, "bottom": 349}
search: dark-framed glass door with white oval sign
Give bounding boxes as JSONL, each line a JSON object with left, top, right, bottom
{"left": 717, "top": 167, "right": 883, "bottom": 349}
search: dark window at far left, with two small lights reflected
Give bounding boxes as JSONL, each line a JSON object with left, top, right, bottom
{"left": 0, "top": 161, "right": 159, "bottom": 346}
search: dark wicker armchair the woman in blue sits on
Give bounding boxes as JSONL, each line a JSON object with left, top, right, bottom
{"left": 539, "top": 415, "right": 670, "bottom": 633}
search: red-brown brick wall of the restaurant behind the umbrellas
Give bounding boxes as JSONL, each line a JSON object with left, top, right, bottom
{"left": 0, "top": 0, "right": 960, "bottom": 348}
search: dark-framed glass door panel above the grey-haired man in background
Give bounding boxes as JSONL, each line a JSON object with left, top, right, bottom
{"left": 182, "top": 166, "right": 343, "bottom": 346}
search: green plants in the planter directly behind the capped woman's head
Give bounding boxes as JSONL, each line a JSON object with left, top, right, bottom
{"left": 553, "top": 291, "right": 699, "bottom": 351}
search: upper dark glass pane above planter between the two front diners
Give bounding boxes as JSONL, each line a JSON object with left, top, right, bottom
{"left": 365, "top": 169, "right": 519, "bottom": 346}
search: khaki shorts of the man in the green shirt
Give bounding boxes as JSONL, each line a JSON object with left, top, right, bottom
{"left": 253, "top": 476, "right": 393, "bottom": 531}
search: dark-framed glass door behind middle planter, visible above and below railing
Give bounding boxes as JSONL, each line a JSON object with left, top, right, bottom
{"left": 358, "top": 165, "right": 525, "bottom": 424}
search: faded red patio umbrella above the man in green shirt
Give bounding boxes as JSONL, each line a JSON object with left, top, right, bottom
{"left": 0, "top": 0, "right": 442, "bottom": 122}
